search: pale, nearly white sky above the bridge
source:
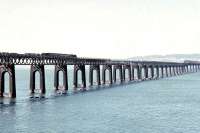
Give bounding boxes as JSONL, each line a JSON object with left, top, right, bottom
{"left": 0, "top": 0, "right": 200, "bottom": 58}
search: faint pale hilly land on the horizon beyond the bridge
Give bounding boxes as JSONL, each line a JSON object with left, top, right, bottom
{"left": 128, "top": 54, "right": 200, "bottom": 62}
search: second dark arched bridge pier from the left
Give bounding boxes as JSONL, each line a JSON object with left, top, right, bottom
{"left": 30, "top": 64, "right": 46, "bottom": 94}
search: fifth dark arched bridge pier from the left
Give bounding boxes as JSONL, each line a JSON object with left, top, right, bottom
{"left": 89, "top": 65, "right": 101, "bottom": 86}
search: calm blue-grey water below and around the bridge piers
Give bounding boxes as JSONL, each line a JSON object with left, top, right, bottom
{"left": 0, "top": 68, "right": 200, "bottom": 133}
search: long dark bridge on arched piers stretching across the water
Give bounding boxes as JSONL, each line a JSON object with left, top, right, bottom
{"left": 0, "top": 53, "right": 200, "bottom": 98}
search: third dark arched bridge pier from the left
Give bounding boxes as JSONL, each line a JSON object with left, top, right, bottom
{"left": 54, "top": 65, "right": 68, "bottom": 91}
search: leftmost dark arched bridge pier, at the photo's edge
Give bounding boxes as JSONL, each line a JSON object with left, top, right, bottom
{"left": 0, "top": 64, "right": 16, "bottom": 98}
